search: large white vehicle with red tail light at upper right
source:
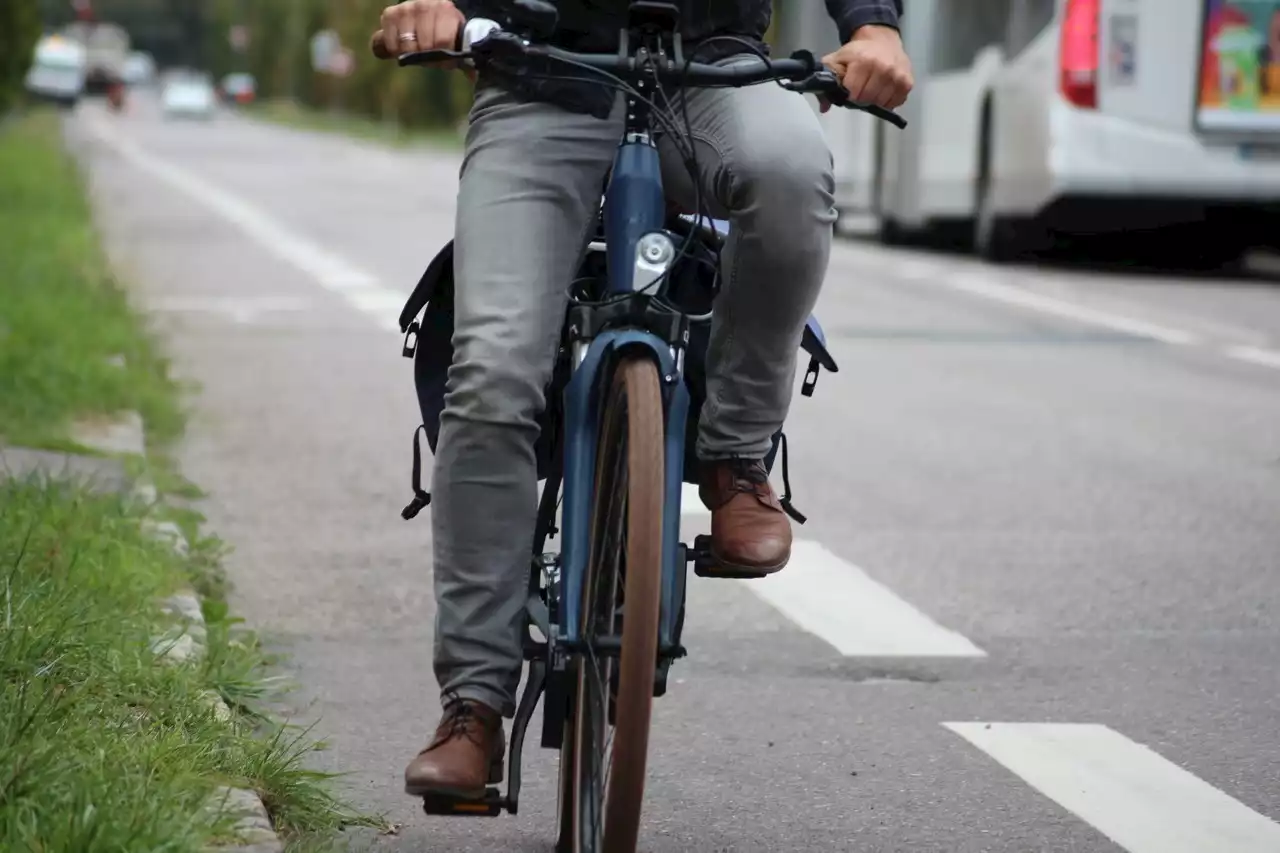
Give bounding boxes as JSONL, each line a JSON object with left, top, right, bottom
{"left": 773, "top": 0, "right": 1280, "bottom": 265}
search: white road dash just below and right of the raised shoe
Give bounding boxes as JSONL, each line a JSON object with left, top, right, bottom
{"left": 741, "top": 540, "right": 987, "bottom": 657}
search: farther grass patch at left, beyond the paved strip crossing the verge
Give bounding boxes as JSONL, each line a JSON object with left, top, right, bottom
{"left": 0, "top": 111, "right": 182, "bottom": 450}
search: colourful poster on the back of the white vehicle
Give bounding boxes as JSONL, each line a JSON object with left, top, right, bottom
{"left": 1196, "top": 0, "right": 1280, "bottom": 133}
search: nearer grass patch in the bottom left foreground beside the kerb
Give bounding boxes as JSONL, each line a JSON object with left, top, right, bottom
{"left": 0, "top": 482, "right": 369, "bottom": 853}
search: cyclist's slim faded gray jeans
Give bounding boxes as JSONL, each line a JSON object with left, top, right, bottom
{"left": 431, "top": 69, "right": 836, "bottom": 716}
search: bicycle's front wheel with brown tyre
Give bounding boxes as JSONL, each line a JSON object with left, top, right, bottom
{"left": 561, "top": 357, "right": 664, "bottom": 853}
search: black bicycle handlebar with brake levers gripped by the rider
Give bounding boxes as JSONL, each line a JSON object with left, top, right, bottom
{"left": 374, "top": 18, "right": 906, "bottom": 128}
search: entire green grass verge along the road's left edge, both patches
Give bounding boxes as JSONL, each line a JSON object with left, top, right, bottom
{"left": 0, "top": 113, "right": 380, "bottom": 853}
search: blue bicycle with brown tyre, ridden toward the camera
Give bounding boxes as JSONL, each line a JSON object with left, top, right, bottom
{"left": 398, "top": 0, "right": 906, "bottom": 853}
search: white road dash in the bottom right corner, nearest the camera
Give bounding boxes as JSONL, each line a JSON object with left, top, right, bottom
{"left": 943, "top": 722, "right": 1280, "bottom": 853}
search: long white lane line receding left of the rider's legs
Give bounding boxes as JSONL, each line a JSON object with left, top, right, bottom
{"left": 86, "top": 120, "right": 407, "bottom": 330}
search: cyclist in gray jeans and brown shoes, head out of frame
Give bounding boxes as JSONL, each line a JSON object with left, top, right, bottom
{"left": 371, "top": 0, "right": 913, "bottom": 798}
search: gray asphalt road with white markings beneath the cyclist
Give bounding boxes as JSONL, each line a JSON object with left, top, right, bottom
{"left": 69, "top": 102, "right": 1280, "bottom": 853}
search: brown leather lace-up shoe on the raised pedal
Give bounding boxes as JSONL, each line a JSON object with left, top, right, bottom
{"left": 698, "top": 459, "right": 791, "bottom": 578}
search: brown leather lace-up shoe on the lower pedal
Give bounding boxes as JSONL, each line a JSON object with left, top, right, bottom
{"left": 404, "top": 699, "right": 506, "bottom": 799}
